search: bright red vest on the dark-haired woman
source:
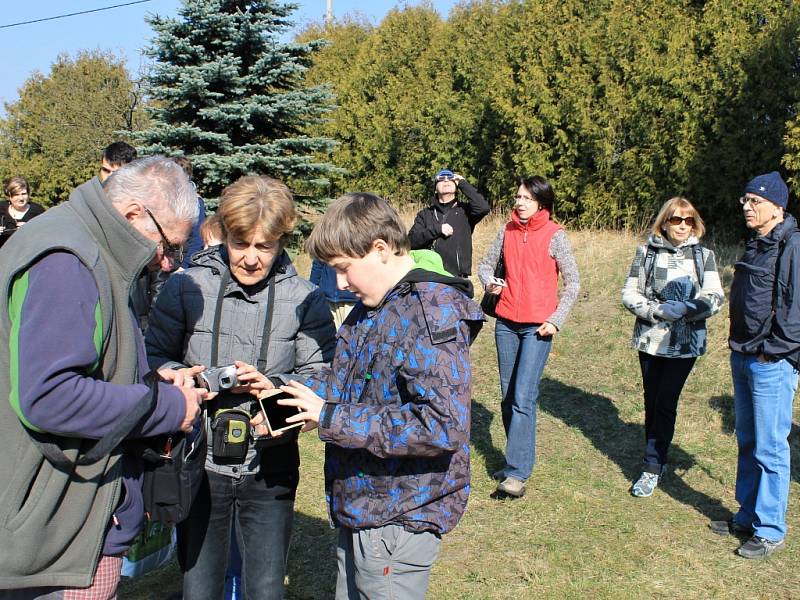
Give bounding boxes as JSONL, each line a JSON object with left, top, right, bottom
{"left": 497, "top": 210, "right": 561, "bottom": 323}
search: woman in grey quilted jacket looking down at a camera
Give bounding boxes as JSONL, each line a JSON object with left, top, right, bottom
{"left": 146, "top": 177, "right": 335, "bottom": 600}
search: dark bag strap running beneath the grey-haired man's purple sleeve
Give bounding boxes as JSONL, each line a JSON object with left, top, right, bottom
{"left": 29, "top": 371, "right": 160, "bottom": 471}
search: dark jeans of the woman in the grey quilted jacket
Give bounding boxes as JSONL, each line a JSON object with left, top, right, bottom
{"left": 178, "top": 471, "right": 299, "bottom": 600}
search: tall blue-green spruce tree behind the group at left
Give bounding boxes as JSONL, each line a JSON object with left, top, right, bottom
{"left": 136, "top": 0, "right": 338, "bottom": 202}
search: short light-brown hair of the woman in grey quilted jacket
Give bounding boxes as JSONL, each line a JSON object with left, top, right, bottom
{"left": 217, "top": 175, "right": 297, "bottom": 246}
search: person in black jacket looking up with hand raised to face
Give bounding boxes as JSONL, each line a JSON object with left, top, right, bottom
{"left": 408, "top": 169, "right": 489, "bottom": 277}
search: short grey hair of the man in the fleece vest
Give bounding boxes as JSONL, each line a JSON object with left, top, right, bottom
{"left": 103, "top": 156, "right": 197, "bottom": 229}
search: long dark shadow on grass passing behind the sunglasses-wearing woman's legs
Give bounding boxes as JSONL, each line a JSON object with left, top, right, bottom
{"left": 539, "top": 377, "right": 732, "bottom": 519}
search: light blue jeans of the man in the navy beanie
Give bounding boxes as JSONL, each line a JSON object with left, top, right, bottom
{"left": 731, "top": 352, "right": 797, "bottom": 542}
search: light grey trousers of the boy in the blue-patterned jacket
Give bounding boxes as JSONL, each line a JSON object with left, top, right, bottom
{"left": 336, "top": 524, "right": 441, "bottom": 600}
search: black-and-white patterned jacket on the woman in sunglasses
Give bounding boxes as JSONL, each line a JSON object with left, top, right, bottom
{"left": 622, "top": 234, "right": 725, "bottom": 358}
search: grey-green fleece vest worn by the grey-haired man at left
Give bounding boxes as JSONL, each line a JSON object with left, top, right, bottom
{"left": 0, "top": 178, "right": 155, "bottom": 597}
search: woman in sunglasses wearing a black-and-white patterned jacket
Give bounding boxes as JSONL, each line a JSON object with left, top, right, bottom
{"left": 622, "top": 197, "right": 724, "bottom": 498}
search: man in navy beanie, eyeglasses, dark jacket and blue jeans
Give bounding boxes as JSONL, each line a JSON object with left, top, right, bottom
{"left": 710, "top": 171, "right": 800, "bottom": 558}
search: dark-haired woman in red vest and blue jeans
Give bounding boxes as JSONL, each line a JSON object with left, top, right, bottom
{"left": 478, "top": 177, "right": 580, "bottom": 498}
